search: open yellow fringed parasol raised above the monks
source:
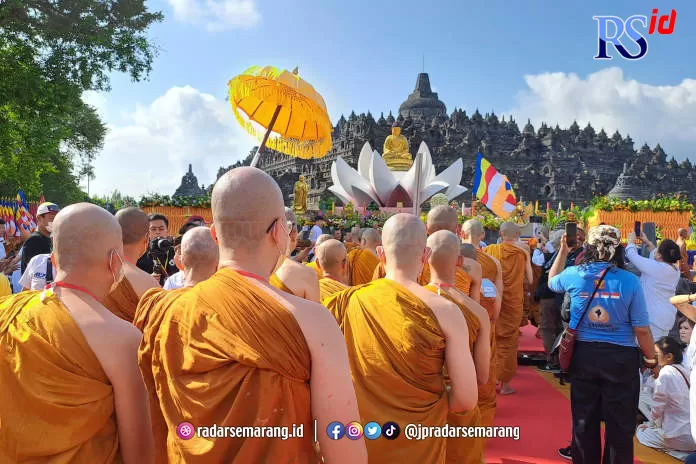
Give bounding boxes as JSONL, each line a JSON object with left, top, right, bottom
{"left": 228, "top": 66, "right": 333, "bottom": 166}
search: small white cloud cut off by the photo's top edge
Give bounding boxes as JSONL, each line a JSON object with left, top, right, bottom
{"left": 169, "top": 0, "right": 261, "bottom": 32}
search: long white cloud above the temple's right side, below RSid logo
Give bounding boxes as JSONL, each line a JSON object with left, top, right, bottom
{"left": 508, "top": 68, "right": 696, "bottom": 160}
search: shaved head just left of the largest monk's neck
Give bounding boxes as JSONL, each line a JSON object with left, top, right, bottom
{"left": 181, "top": 226, "right": 220, "bottom": 287}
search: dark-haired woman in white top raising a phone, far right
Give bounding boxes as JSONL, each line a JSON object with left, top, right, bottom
{"left": 626, "top": 232, "right": 681, "bottom": 340}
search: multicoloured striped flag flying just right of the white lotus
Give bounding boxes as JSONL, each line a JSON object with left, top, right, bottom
{"left": 473, "top": 153, "right": 517, "bottom": 218}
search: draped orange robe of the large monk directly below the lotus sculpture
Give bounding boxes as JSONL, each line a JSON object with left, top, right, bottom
{"left": 324, "top": 279, "right": 448, "bottom": 464}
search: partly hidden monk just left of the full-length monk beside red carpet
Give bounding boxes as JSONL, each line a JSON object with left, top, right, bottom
{"left": 461, "top": 219, "right": 503, "bottom": 426}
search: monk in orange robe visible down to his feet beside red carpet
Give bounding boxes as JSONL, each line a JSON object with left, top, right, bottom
{"left": 484, "top": 222, "right": 532, "bottom": 395}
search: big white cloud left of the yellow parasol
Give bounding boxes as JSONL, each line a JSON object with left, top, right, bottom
{"left": 90, "top": 86, "right": 254, "bottom": 198}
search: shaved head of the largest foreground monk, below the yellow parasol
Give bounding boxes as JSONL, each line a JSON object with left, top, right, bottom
{"left": 211, "top": 167, "right": 290, "bottom": 279}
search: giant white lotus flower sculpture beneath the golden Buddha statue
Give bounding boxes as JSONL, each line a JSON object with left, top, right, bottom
{"left": 329, "top": 142, "right": 467, "bottom": 207}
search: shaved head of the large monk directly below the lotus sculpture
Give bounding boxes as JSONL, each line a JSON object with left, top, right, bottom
{"left": 378, "top": 213, "right": 430, "bottom": 282}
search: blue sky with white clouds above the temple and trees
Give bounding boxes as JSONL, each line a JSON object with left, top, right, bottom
{"left": 86, "top": 0, "right": 696, "bottom": 195}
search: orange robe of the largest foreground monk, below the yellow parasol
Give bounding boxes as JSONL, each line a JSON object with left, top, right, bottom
{"left": 138, "top": 268, "right": 317, "bottom": 464}
